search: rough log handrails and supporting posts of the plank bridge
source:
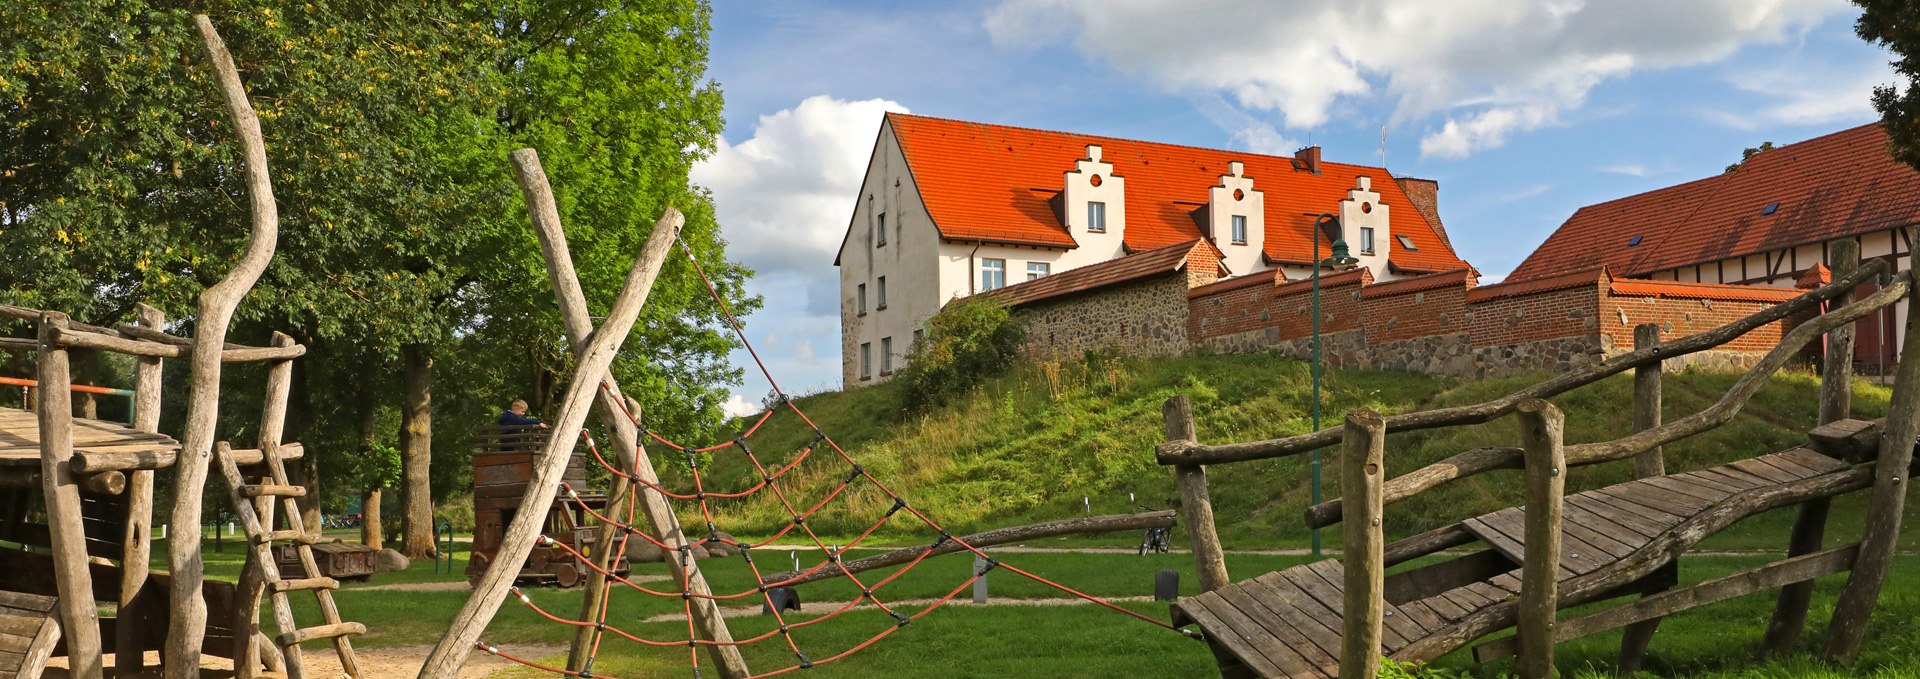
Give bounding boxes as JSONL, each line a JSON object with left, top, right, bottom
{"left": 1156, "top": 240, "right": 1920, "bottom": 677}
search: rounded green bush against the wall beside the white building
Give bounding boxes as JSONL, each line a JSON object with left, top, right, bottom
{"left": 897, "top": 297, "right": 1027, "bottom": 410}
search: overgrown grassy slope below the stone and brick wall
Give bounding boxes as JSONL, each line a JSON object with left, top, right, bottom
{"left": 670, "top": 355, "right": 1887, "bottom": 549}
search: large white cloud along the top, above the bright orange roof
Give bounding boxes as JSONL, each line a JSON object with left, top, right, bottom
{"left": 985, "top": 0, "right": 1849, "bottom": 157}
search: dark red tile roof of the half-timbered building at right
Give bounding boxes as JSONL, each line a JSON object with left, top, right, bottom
{"left": 1509, "top": 123, "right": 1920, "bottom": 280}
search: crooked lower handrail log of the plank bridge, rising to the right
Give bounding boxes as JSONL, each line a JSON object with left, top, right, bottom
{"left": 1308, "top": 270, "right": 1912, "bottom": 527}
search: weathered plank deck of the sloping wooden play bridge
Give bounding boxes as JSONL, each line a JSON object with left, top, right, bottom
{"left": 1173, "top": 449, "right": 1849, "bottom": 677}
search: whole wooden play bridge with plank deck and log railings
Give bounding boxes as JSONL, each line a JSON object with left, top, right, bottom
{"left": 1156, "top": 240, "right": 1920, "bottom": 679}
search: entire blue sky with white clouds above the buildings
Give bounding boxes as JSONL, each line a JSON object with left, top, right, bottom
{"left": 693, "top": 0, "right": 1895, "bottom": 414}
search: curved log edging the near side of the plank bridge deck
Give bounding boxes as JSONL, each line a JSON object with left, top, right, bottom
{"left": 1392, "top": 468, "right": 1872, "bottom": 662}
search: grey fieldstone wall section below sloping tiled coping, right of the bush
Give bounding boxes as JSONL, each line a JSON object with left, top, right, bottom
{"left": 1016, "top": 272, "right": 1190, "bottom": 359}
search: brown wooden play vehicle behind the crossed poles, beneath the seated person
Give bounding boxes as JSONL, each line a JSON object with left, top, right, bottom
{"left": 467, "top": 426, "right": 632, "bottom": 587}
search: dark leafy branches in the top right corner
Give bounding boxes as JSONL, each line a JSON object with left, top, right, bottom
{"left": 1853, "top": 0, "right": 1920, "bottom": 169}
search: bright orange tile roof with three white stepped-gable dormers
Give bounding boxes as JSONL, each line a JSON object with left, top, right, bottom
{"left": 887, "top": 113, "right": 1465, "bottom": 270}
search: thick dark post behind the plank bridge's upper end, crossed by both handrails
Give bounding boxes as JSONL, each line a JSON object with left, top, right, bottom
{"left": 1761, "top": 238, "right": 1860, "bottom": 656}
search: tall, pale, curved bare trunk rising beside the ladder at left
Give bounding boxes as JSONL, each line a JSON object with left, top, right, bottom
{"left": 165, "top": 13, "right": 280, "bottom": 679}
